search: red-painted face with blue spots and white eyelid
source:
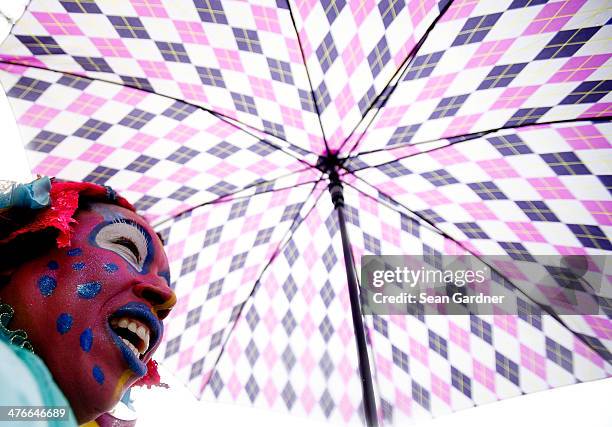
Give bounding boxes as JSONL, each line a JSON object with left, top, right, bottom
{"left": 0, "top": 203, "right": 176, "bottom": 422}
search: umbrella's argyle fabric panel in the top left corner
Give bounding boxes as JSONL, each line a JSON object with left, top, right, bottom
{"left": 0, "top": 0, "right": 325, "bottom": 154}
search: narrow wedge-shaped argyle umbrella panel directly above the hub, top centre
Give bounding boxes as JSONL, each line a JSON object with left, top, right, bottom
{"left": 290, "top": 0, "right": 446, "bottom": 151}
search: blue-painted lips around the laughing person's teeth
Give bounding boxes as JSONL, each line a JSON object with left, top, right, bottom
{"left": 108, "top": 302, "right": 164, "bottom": 376}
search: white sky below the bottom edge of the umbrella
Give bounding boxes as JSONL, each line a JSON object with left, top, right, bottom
{"left": 126, "top": 367, "right": 612, "bottom": 427}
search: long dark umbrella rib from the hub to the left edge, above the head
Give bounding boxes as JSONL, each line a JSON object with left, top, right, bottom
{"left": 0, "top": 59, "right": 317, "bottom": 165}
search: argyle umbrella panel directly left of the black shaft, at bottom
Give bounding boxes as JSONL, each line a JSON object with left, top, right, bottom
{"left": 202, "top": 186, "right": 368, "bottom": 425}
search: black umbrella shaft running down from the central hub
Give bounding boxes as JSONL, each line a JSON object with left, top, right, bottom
{"left": 329, "top": 173, "right": 378, "bottom": 427}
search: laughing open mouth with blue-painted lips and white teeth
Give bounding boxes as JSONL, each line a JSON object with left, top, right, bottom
{"left": 108, "top": 303, "right": 163, "bottom": 375}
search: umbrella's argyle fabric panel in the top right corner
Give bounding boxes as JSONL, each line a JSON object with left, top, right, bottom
{"left": 350, "top": 0, "right": 612, "bottom": 152}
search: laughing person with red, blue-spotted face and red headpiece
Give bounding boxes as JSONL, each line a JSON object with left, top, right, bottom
{"left": 0, "top": 178, "right": 176, "bottom": 426}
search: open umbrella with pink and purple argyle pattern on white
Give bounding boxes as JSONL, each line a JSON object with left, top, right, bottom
{"left": 0, "top": 0, "right": 612, "bottom": 426}
